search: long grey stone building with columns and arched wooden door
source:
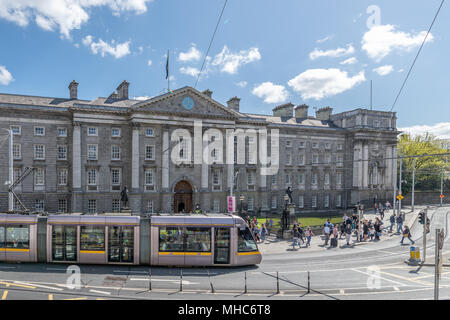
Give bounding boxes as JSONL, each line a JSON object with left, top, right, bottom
{"left": 0, "top": 81, "right": 399, "bottom": 214}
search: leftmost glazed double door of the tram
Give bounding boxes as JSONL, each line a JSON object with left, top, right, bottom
{"left": 52, "top": 226, "right": 77, "bottom": 261}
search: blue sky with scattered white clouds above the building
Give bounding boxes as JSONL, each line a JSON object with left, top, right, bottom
{"left": 0, "top": 0, "right": 450, "bottom": 138}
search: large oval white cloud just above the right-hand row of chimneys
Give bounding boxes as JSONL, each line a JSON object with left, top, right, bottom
{"left": 288, "top": 69, "right": 366, "bottom": 100}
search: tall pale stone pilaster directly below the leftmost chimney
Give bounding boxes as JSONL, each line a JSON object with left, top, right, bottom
{"left": 72, "top": 122, "right": 83, "bottom": 212}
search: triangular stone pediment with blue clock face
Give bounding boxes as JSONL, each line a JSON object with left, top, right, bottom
{"left": 132, "top": 87, "right": 240, "bottom": 119}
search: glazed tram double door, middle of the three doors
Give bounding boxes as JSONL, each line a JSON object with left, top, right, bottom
{"left": 108, "top": 226, "right": 134, "bottom": 262}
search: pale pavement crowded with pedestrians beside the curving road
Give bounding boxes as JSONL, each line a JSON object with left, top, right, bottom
{"left": 258, "top": 206, "right": 425, "bottom": 255}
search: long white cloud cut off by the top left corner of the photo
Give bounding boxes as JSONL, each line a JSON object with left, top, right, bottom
{"left": 0, "top": 0, "right": 152, "bottom": 38}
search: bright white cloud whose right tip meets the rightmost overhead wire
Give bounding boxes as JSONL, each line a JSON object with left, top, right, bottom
{"left": 361, "top": 24, "right": 433, "bottom": 62}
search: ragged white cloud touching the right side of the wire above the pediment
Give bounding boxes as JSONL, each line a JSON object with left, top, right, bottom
{"left": 211, "top": 46, "right": 261, "bottom": 74}
